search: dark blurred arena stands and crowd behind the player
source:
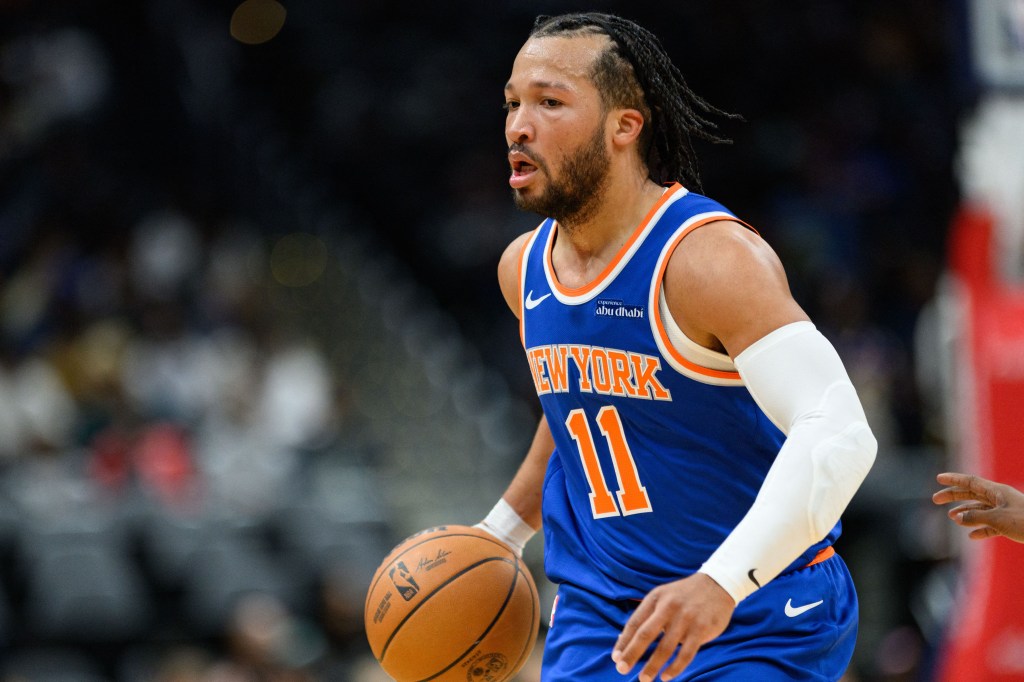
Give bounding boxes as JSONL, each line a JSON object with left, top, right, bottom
{"left": 0, "top": 0, "right": 1007, "bottom": 682}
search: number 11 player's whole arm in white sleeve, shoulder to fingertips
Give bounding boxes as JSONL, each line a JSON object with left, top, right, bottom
{"left": 612, "top": 221, "right": 877, "bottom": 681}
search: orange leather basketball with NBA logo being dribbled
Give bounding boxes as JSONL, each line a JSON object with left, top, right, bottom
{"left": 364, "top": 525, "right": 540, "bottom": 682}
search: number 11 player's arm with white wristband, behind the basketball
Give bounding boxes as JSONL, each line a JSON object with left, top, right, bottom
{"left": 477, "top": 232, "right": 555, "bottom": 554}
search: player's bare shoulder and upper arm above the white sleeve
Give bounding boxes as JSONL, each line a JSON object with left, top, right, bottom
{"left": 665, "top": 221, "right": 808, "bottom": 357}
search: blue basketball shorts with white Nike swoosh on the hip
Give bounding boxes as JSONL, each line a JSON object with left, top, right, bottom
{"left": 541, "top": 555, "right": 857, "bottom": 682}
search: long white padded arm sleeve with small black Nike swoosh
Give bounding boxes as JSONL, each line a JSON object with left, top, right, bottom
{"left": 700, "top": 322, "right": 878, "bottom": 603}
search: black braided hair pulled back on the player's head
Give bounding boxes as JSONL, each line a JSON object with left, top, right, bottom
{"left": 529, "top": 12, "right": 741, "bottom": 189}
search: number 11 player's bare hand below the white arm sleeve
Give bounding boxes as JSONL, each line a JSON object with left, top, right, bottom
{"left": 611, "top": 573, "right": 736, "bottom": 682}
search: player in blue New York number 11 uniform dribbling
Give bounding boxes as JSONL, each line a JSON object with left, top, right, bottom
{"left": 479, "top": 13, "right": 877, "bottom": 682}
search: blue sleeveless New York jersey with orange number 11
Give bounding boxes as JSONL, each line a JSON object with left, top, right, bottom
{"left": 520, "top": 184, "right": 840, "bottom": 599}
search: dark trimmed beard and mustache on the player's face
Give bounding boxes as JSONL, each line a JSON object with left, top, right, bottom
{"left": 512, "top": 126, "right": 611, "bottom": 229}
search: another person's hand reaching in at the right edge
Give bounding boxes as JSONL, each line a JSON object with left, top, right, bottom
{"left": 932, "top": 473, "right": 1024, "bottom": 543}
